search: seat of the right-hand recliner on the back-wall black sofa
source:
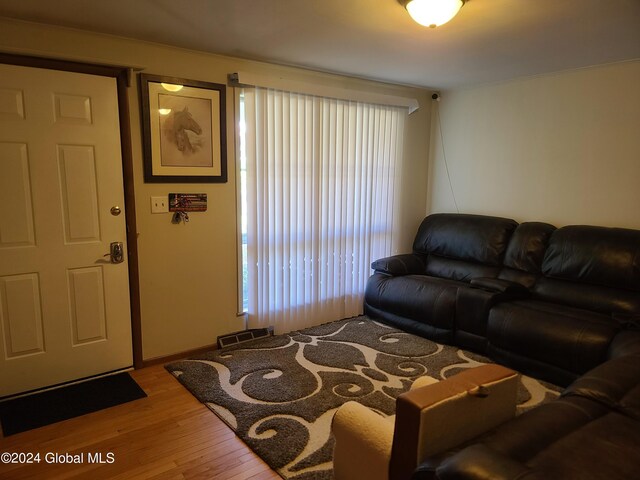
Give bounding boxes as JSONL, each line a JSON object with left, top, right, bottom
{"left": 487, "top": 300, "right": 620, "bottom": 385}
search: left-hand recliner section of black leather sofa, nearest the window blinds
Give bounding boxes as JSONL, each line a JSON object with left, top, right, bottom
{"left": 364, "top": 214, "right": 517, "bottom": 344}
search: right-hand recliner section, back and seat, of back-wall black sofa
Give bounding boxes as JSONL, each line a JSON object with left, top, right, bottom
{"left": 487, "top": 226, "right": 640, "bottom": 385}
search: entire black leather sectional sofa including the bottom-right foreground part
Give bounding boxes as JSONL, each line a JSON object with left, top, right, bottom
{"left": 365, "top": 214, "right": 640, "bottom": 479}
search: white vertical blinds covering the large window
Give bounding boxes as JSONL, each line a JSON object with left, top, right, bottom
{"left": 242, "top": 87, "right": 407, "bottom": 332}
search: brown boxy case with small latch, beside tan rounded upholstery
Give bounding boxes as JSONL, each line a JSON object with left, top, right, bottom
{"left": 389, "top": 365, "right": 518, "bottom": 480}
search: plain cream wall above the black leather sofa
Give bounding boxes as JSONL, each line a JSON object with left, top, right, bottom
{"left": 428, "top": 61, "right": 640, "bottom": 228}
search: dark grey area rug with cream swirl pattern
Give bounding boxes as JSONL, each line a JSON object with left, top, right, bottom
{"left": 166, "top": 317, "right": 561, "bottom": 480}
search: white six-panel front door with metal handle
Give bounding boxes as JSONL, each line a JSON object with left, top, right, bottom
{"left": 0, "top": 65, "right": 133, "bottom": 397}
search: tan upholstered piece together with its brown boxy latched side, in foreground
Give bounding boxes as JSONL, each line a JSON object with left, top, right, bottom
{"left": 332, "top": 365, "right": 519, "bottom": 480}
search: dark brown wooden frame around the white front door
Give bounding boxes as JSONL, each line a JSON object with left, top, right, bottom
{"left": 0, "top": 52, "right": 144, "bottom": 369}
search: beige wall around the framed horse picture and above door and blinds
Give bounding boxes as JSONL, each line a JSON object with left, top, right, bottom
{"left": 0, "top": 18, "right": 430, "bottom": 359}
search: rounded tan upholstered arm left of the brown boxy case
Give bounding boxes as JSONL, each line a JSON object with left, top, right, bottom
{"left": 331, "top": 402, "right": 393, "bottom": 480}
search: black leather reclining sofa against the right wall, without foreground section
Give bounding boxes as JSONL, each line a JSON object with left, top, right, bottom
{"left": 364, "top": 214, "right": 640, "bottom": 386}
